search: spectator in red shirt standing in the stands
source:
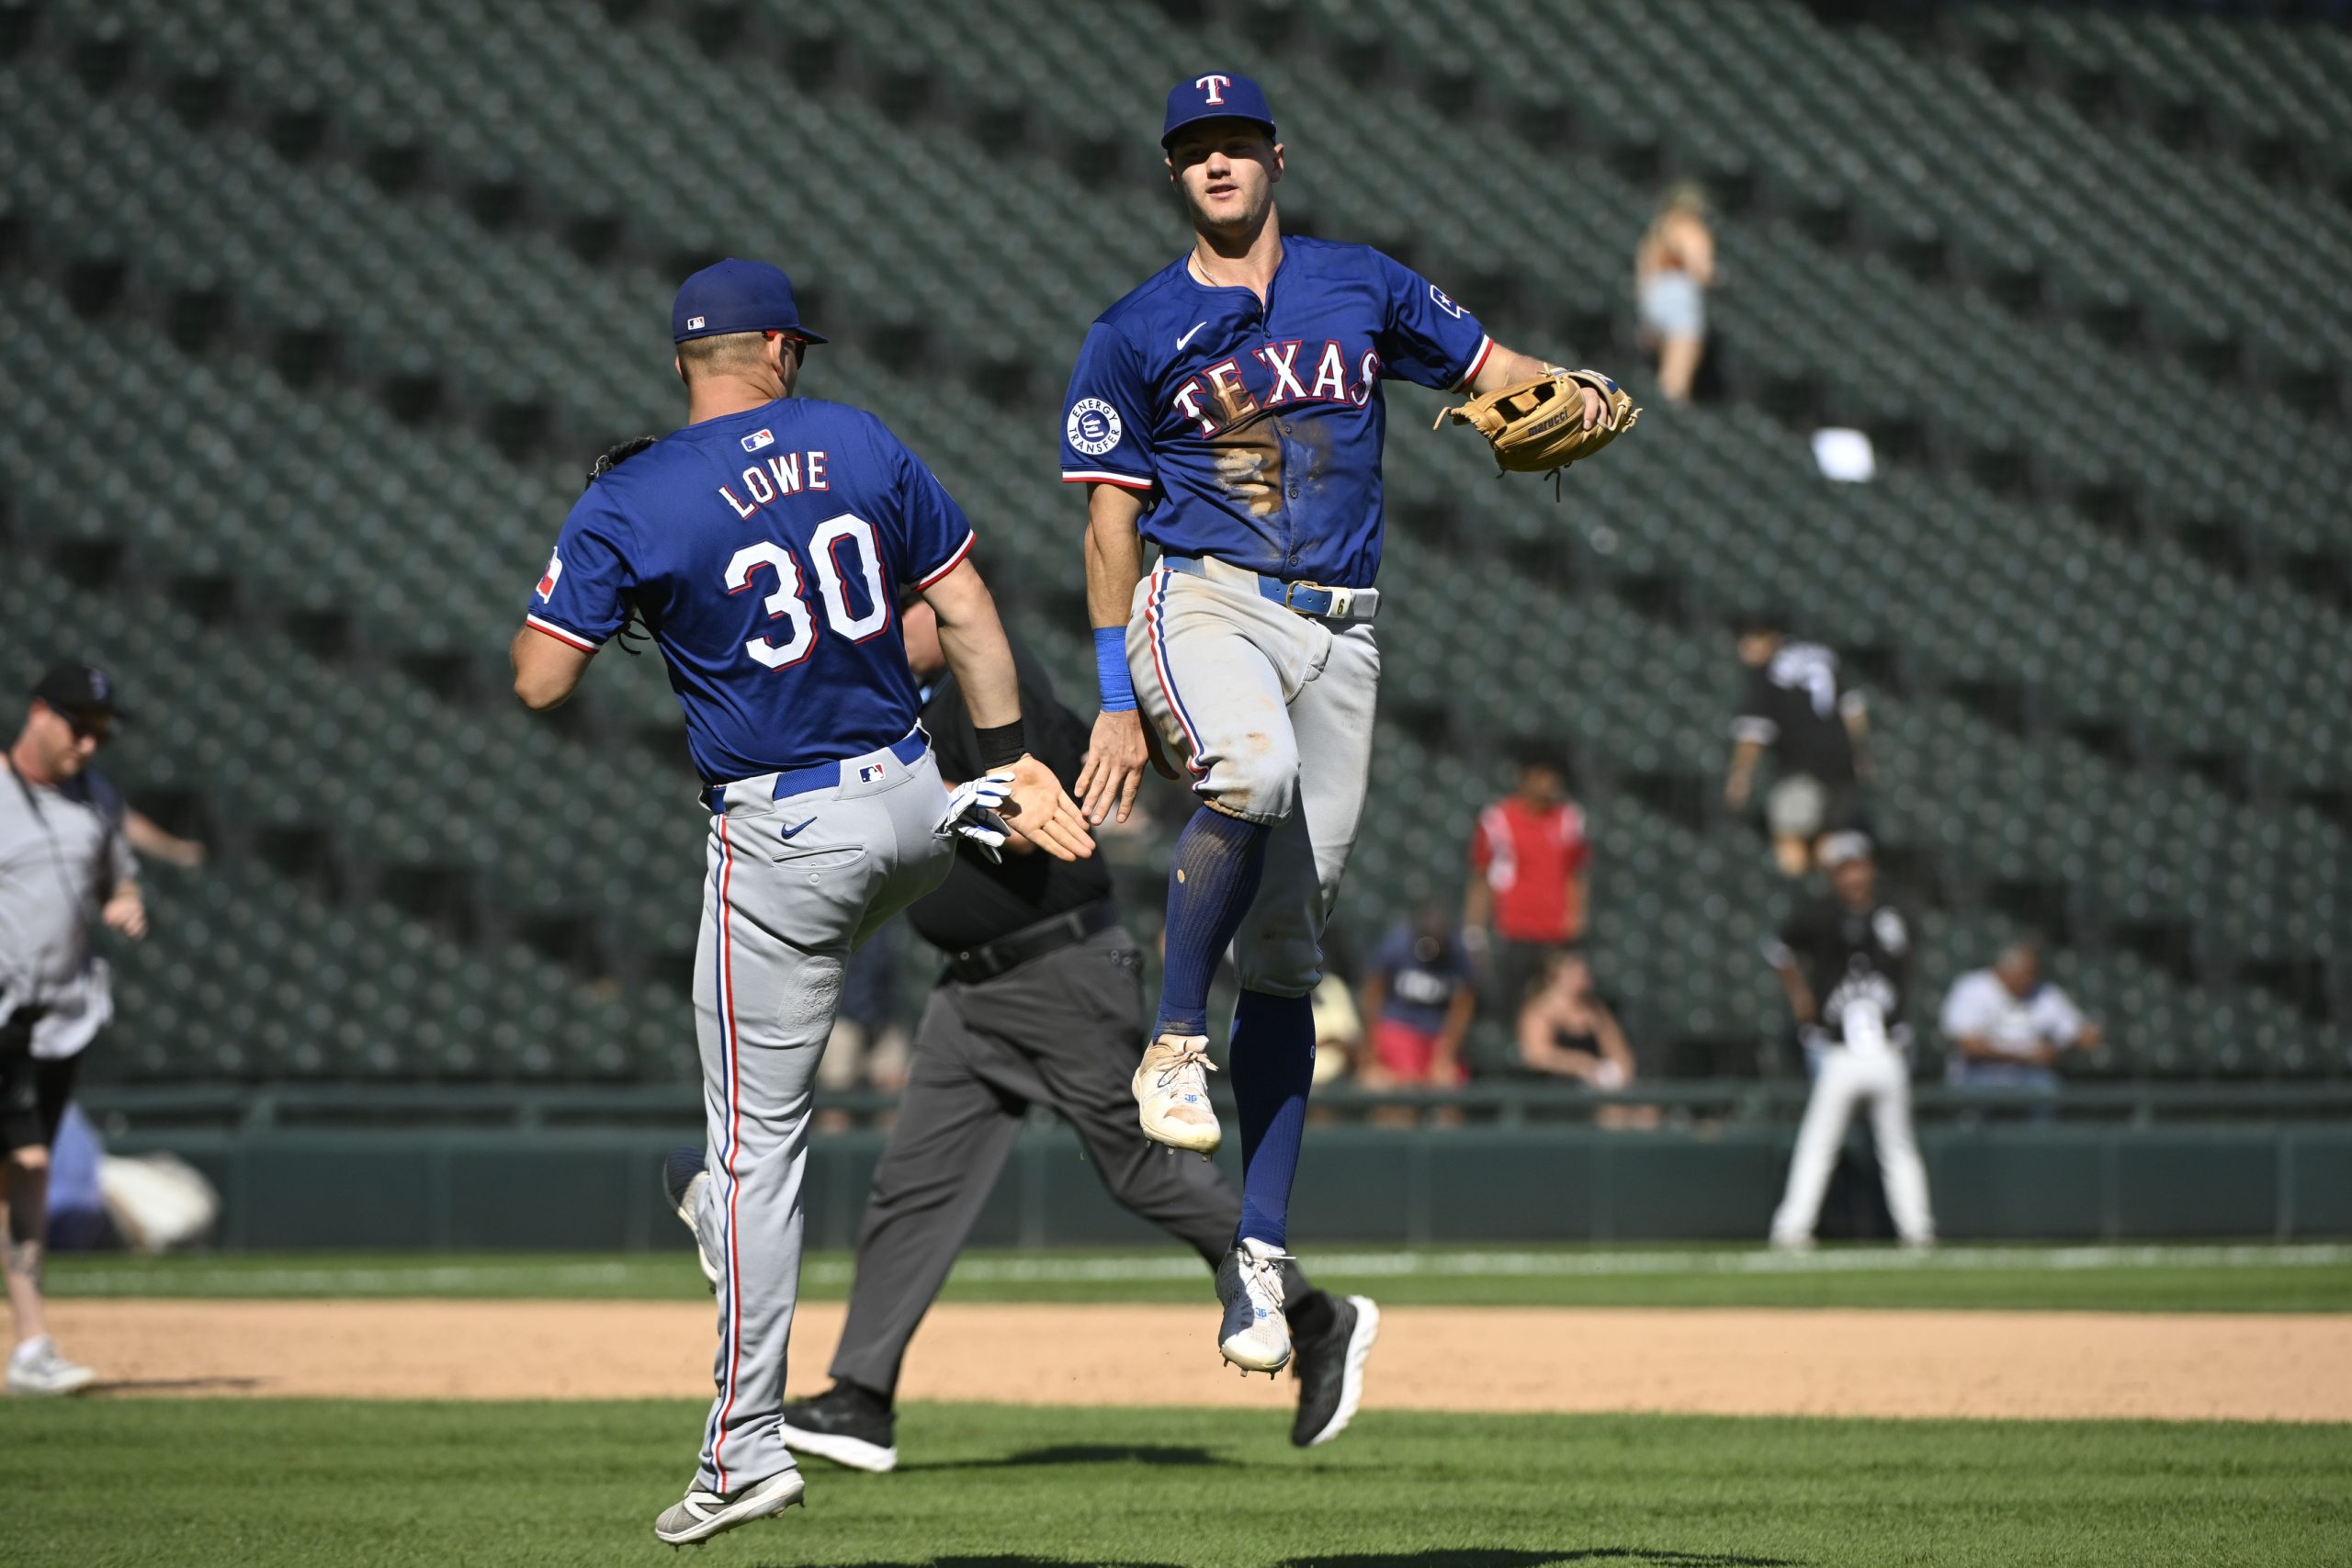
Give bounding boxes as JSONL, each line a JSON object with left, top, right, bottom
{"left": 1463, "top": 750, "right": 1592, "bottom": 1018}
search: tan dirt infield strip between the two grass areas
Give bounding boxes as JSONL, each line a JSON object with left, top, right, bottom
{"left": 51, "top": 1300, "right": 2352, "bottom": 1420}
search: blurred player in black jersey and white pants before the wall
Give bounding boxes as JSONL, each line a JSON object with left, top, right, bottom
{"left": 1767, "top": 832, "right": 1936, "bottom": 1251}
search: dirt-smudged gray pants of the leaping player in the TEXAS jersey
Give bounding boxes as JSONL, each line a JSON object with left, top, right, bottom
{"left": 1126, "top": 559, "right": 1381, "bottom": 997}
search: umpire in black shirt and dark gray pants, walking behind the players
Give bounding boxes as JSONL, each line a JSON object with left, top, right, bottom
{"left": 783, "top": 600, "right": 1381, "bottom": 1472}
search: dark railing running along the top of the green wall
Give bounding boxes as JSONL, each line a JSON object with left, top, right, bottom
{"left": 80, "top": 1079, "right": 2352, "bottom": 1131}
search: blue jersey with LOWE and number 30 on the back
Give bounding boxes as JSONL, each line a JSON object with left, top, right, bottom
{"left": 526, "top": 398, "right": 971, "bottom": 783}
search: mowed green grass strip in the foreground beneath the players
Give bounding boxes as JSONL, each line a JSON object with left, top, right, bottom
{"left": 0, "top": 1401, "right": 2352, "bottom": 1568}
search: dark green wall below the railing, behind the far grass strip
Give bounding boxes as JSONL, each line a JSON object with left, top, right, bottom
{"left": 115, "top": 1126, "right": 2352, "bottom": 1251}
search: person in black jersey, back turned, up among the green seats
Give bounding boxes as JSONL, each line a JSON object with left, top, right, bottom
{"left": 1724, "top": 614, "right": 1870, "bottom": 877}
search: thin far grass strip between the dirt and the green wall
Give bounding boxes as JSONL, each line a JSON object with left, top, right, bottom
{"left": 51, "top": 1244, "right": 2352, "bottom": 1312}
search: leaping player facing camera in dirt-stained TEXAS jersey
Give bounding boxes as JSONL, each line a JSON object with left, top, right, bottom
{"left": 1061, "top": 73, "right": 1604, "bottom": 1371}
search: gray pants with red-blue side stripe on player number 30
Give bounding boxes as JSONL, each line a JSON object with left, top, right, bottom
{"left": 694, "top": 750, "right": 955, "bottom": 1493}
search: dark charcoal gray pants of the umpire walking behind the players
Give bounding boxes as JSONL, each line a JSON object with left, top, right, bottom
{"left": 832, "top": 926, "right": 1307, "bottom": 1396}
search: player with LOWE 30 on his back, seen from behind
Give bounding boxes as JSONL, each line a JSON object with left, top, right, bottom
{"left": 513, "top": 261, "right": 1093, "bottom": 1544}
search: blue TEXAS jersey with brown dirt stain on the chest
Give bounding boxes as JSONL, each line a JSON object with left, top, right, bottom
{"left": 1061, "top": 235, "right": 1494, "bottom": 588}
